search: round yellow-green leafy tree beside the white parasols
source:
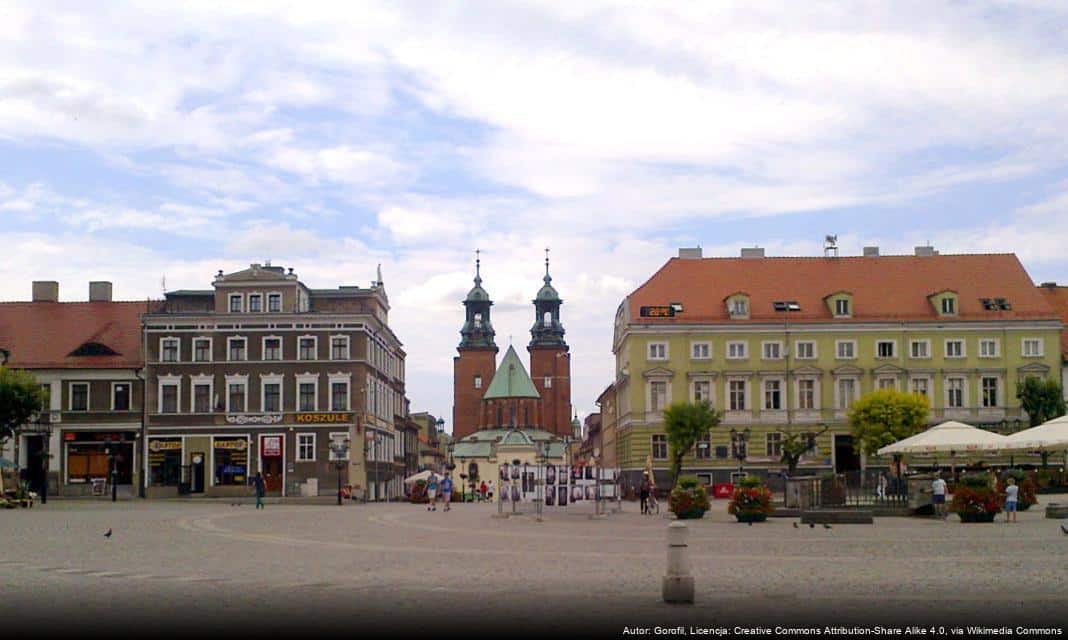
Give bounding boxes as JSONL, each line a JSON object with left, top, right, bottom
{"left": 849, "top": 389, "right": 930, "bottom": 461}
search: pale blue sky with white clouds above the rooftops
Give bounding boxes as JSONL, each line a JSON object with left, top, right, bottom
{"left": 0, "top": 0, "right": 1068, "bottom": 430}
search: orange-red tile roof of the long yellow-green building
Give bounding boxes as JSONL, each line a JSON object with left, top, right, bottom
{"left": 629, "top": 253, "right": 1057, "bottom": 324}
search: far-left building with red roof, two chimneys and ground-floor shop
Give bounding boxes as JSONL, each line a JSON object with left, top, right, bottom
{"left": 0, "top": 281, "right": 150, "bottom": 498}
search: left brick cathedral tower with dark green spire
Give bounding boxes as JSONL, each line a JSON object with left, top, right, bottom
{"left": 453, "top": 251, "right": 497, "bottom": 439}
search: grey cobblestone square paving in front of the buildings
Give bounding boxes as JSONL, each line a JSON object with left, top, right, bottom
{"left": 0, "top": 497, "right": 1068, "bottom": 636}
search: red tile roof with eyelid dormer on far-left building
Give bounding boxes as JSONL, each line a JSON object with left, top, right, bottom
{"left": 0, "top": 302, "right": 148, "bottom": 369}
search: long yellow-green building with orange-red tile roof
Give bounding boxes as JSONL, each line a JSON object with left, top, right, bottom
{"left": 602, "top": 247, "right": 1063, "bottom": 483}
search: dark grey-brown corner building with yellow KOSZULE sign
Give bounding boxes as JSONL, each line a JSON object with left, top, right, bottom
{"left": 142, "top": 264, "right": 410, "bottom": 500}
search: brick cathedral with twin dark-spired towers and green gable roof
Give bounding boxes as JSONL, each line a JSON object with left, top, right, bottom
{"left": 453, "top": 257, "right": 572, "bottom": 439}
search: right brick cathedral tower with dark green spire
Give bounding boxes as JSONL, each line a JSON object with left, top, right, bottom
{"left": 527, "top": 249, "right": 571, "bottom": 437}
